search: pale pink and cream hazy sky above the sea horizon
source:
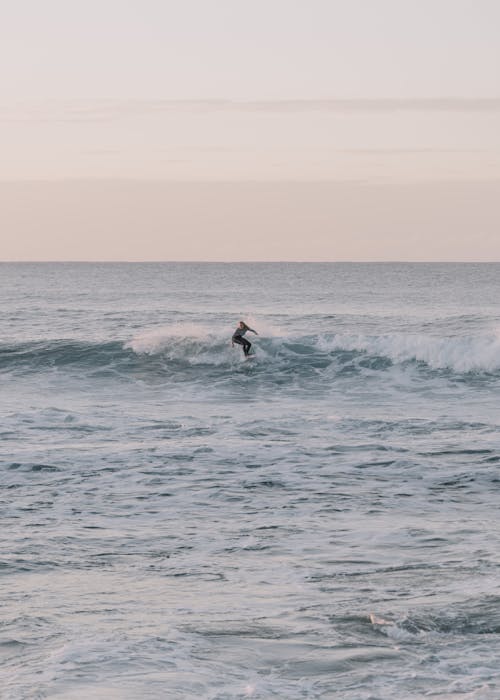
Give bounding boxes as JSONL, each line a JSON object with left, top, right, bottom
{"left": 0, "top": 0, "right": 500, "bottom": 260}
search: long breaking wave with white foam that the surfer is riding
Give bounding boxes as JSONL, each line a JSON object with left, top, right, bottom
{"left": 0, "top": 324, "right": 500, "bottom": 374}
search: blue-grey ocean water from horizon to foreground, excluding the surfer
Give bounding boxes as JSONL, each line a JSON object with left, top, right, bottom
{"left": 0, "top": 263, "right": 500, "bottom": 700}
